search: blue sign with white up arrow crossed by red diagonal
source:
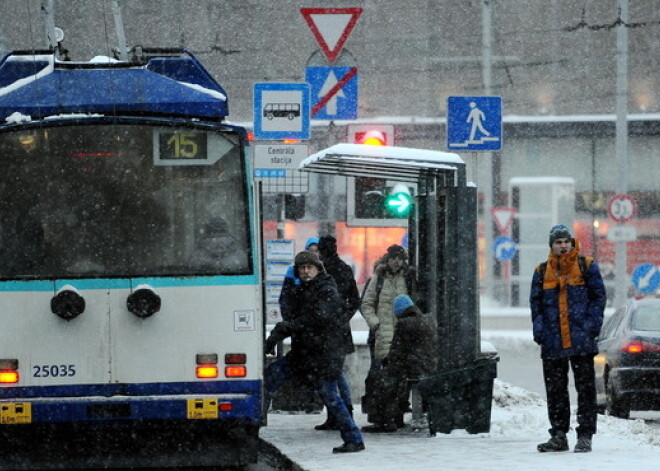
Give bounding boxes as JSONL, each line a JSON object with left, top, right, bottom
{"left": 305, "top": 67, "right": 358, "bottom": 119}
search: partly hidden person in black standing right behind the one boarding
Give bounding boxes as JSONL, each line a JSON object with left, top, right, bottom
{"left": 314, "top": 235, "right": 360, "bottom": 430}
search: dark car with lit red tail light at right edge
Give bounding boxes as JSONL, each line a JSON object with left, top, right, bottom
{"left": 595, "top": 299, "right": 660, "bottom": 418}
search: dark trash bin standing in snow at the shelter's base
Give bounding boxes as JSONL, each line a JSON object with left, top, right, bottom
{"left": 418, "top": 355, "right": 499, "bottom": 435}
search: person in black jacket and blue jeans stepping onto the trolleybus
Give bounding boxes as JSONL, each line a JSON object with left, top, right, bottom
{"left": 266, "top": 251, "right": 364, "bottom": 453}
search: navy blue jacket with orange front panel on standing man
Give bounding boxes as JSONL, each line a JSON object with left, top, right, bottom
{"left": 529, "top": 244, "right": 606, "bottom": 359}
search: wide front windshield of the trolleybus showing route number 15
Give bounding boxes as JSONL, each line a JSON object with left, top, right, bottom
{"left": 0, "top": 124, "right": 252, "bottom": 280}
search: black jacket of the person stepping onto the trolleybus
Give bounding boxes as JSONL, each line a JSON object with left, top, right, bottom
{"left": 268, "top": 273, "right": 345, "bottom": 381}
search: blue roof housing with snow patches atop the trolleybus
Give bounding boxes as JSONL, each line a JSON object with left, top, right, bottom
{"left": 0, "top": 49, "right": 228, "bottom": 124}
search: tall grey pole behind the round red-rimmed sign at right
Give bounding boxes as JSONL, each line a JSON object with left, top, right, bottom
{"left": 614, "top": 0, "right": 628, "bottom": 307}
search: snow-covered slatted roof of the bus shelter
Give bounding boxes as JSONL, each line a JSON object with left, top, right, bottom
{"left": 298, "top": 144, "right": 466, "bottom": 185}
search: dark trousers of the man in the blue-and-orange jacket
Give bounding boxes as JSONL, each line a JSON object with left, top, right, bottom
{"left": 543, "top": 355, "right": 598, "bottom": 436}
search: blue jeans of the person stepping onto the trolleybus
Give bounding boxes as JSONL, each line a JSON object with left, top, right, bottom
{"left": 266, "top": 355, "right": 362, "bottom": 443}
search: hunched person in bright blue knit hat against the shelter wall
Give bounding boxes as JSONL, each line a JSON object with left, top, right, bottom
{"left": 362, "top": 294, "right": 438, "bottom": 432}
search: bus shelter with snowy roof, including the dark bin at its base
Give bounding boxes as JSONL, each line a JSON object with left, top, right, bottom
{"left": 299, "top": 144, "right": 497, "bottom": 433}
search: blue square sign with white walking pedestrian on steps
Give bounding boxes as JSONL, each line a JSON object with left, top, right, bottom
{"left": 447, "top": 96, "right": 502, "bottom": 151}
